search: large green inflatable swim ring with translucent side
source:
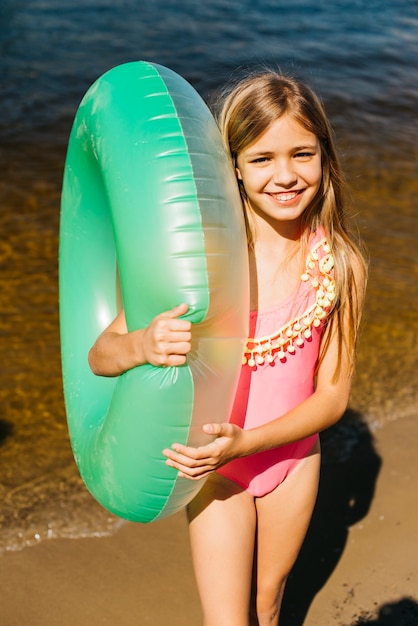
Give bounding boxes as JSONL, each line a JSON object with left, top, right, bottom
{"left": 59, "top": 61, "right": 248, "bottom": 522}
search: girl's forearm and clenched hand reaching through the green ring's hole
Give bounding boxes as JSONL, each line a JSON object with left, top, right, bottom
{"left": 88, "top": 304, "right": 191, "bottom": 376}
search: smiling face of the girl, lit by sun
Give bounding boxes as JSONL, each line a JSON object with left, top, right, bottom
{"left": 236, "top": 115, "right": 322, "bottom": 228}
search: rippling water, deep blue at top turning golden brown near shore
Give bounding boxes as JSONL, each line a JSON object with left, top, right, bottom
{"left": 0, "top": 0, "right": 418, "bottom": 549}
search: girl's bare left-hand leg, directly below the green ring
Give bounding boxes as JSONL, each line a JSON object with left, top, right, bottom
{"left": 188, "top": 473, "right": 256, "bottom": 626}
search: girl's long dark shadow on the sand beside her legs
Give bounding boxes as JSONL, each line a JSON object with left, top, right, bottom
{"left": 280, "top": 410, "right": 382, "bottom": 626}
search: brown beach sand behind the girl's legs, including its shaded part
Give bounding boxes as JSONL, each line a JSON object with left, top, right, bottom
{"left": 0, "top": 417, "right": 418, "bottom": 626}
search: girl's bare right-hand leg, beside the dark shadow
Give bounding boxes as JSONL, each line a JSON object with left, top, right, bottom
{"left": 253, "top": 443, "right": 320, "bottom": 626}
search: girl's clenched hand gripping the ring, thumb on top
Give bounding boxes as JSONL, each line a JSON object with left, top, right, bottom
{"left": 141, "top": 304, "right": 192, "bottom": 367}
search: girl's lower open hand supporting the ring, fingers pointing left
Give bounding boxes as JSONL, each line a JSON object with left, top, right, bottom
{"left": 163, "top": 424, "right": 245, "bottom": 480}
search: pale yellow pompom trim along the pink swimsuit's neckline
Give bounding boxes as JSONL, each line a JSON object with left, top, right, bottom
{"left": 242, "top": 239, "right": 335, "bottom": 367}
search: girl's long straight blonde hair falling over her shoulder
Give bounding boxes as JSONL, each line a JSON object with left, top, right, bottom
{"left": 217, "top": 69, "right": 367, "bottom": 380}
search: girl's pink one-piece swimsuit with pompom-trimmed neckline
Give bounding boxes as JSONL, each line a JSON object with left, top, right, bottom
{"left": 217, "top": 230, "right": 335, "bottom": 497}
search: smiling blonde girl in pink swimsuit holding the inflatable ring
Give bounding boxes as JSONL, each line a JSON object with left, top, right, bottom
{"left": 89, "top": 71, "right": 367, "bottom": 626}
